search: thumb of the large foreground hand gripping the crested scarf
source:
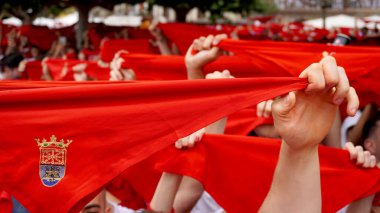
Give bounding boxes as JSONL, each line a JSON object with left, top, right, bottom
{"left": 272, "top": 92, "right": 296, "bottom": 118}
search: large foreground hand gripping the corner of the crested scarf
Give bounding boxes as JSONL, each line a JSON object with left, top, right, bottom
{"left": 272, "top": 56, "right": 359, "bottom": 149}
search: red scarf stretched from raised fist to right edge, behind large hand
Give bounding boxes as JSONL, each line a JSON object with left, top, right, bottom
{"left": 219, "top": 40, "right": 380, "bottom": 106}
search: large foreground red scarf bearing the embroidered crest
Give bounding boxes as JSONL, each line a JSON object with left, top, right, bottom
{"left": 0, "top": 78, "right": 306, "bottom": 212}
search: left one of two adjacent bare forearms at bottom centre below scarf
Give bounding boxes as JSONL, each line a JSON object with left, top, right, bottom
{"left": 150, "top": 172, "right": 182, "bottom": 213}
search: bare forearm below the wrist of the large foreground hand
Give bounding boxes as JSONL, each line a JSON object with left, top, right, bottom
{"left": 259, "top": 142, "right": 322, "bottom": 212}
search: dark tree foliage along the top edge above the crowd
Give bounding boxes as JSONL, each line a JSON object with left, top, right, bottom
{"left": 0, "top": 0, "right": 275, "bottom": 21}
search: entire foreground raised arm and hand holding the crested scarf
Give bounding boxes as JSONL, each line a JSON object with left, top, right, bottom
{"left": 260, "top": 57, "right": 359, "bottom": 212}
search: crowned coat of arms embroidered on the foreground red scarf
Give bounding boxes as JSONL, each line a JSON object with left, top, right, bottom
{"left": 35, "top": 135, "right": 73, "bottom": 187}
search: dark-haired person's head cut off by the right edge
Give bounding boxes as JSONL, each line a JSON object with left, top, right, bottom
{"left": 360, "top": 111, "right": 380, "bottom": 161}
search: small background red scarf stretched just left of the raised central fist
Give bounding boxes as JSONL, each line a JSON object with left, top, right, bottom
{"left": 100, "top": 39, "right": 153, "bottom": 63}
